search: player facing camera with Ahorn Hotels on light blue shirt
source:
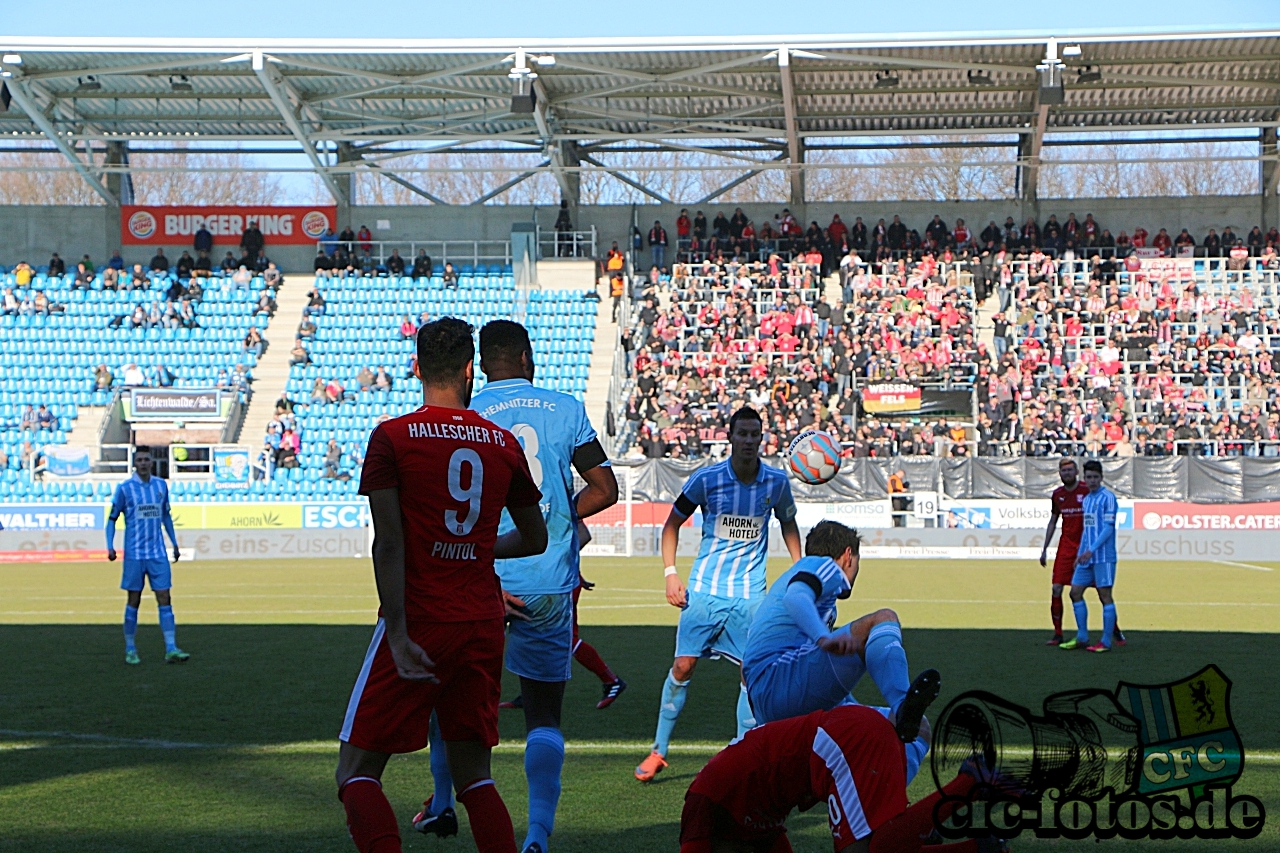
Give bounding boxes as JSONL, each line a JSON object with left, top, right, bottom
{"left": 635, "top": 406, "right": 800, "bottom": 781}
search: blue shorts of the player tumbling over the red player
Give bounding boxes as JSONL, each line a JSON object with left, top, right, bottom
{"left": 744, "top": 643, "right": 867, "bottom": 724}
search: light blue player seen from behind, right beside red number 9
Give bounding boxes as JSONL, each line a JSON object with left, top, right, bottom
{"left": 413, "top": 320, "right": 618, "bottom": 853}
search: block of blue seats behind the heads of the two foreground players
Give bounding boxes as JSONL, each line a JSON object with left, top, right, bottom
{"left": 258, "top": 266, "right": 596, "bottom": 500}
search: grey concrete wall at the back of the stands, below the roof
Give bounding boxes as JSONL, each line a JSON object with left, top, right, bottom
{"left": 0, "top": 196, "right": 1280, "bottom": 272}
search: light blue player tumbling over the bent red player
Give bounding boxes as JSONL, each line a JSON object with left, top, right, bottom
{"left": 742, "top": 521, "right": 941, "bottom": 740}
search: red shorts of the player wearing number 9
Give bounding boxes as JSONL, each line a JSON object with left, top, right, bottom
{"left": 338, "top": 619, "right": 504, "bottom": 753}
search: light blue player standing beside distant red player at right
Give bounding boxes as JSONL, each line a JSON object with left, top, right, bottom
{"left": 1059, "top": 459, "right": 1119, "bottom": 652}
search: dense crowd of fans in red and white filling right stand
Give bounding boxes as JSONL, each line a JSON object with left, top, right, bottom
{"left": 622, "top": 209, "right": 1280, "bottom": 457}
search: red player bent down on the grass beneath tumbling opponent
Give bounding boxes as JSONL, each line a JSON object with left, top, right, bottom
{"left": 680, "top": 704, "right": 1004, "bottom": 853}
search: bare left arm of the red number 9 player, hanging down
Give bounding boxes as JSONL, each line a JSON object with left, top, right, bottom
{"left": 369, "top": 489, "right": 436, "bottom": 681}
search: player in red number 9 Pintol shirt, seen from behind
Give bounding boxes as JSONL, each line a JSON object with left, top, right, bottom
{"left": 337, "top": 318, "right": 547, "bottom": 853}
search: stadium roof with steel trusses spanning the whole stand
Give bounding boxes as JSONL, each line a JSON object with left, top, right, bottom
{"left": 0, "top": 31, "right": 1280, "bottom": 202}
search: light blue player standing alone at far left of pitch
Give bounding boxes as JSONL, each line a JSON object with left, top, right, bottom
{"left": 106, "top": 447, "right": 191, "bottom": 665}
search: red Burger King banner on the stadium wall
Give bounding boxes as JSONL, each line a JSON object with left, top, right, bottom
{"left": 120, "top": 205, "right": 338, "bottom": 246}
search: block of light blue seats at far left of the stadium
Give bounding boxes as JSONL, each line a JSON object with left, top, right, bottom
{"left": 0, "top": 264, "right": 270, "bottom": 501}
